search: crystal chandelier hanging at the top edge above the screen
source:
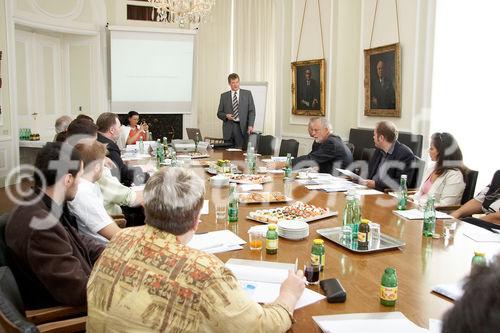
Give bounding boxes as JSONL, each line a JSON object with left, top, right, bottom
{"left": 148, "top": 0, "right": 215, "bottom": 28}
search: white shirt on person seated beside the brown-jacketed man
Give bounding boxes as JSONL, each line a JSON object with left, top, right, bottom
{"left": 68, "top": 178, "right": 114, "bottom": 244}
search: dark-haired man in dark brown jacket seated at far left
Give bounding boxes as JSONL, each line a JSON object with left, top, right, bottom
{"left": 5, "top": 142, "right": 104, "bottom": 309}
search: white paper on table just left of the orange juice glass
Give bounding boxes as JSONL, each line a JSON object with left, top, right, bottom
{"left": 188, "top": 230, "right": 246, "bottom": 253}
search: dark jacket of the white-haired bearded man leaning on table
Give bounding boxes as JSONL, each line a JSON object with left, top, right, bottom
{"left": 292, "top": 134, "right": 352, "bottom": 174}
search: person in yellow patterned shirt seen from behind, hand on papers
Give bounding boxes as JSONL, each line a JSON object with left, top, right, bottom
{"left": 87, "top": 168, "right": 304, "bottom": 333}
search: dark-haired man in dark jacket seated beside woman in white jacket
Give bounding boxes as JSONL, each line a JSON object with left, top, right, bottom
{"left": 362, "top": 121, "right": 415, "bottom": 191}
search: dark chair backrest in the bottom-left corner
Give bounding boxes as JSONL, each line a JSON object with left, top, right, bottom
{"left": 0, "top": 266, "right": 38, "bottom": 333}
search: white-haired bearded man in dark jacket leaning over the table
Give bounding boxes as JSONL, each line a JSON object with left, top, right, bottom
{"left": 292, "top": 117, "right": 352, "bottom": 174}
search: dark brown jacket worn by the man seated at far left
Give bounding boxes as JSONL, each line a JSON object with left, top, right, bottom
{"left": 5, "top": 191, "right": 104, "bottom": 309}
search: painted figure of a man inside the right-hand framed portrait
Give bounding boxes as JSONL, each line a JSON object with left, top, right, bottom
{"left": 371, "top": 60, "right": 396, "bottom": 109}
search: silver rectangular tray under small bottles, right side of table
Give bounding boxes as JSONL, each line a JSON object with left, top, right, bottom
{"left": 316, "top": 227, "right": 406, "bottom": 253}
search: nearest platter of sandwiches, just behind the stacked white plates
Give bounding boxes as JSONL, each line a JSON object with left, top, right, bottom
{"left": 247, "top": 201, "right": 337, "bottom": 223}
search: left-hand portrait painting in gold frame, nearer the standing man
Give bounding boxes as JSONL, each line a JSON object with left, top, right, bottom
{"left": 292, "top": 59, "right": 326, "bottom": 116}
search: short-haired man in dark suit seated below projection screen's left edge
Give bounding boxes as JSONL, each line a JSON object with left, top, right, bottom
{"left": 96, "top": 112, "right": 149, "bottom": 186}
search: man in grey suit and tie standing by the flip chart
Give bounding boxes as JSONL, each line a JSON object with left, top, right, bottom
{"left": 217, "top": 73, "right": 255, "bottom": 148}
